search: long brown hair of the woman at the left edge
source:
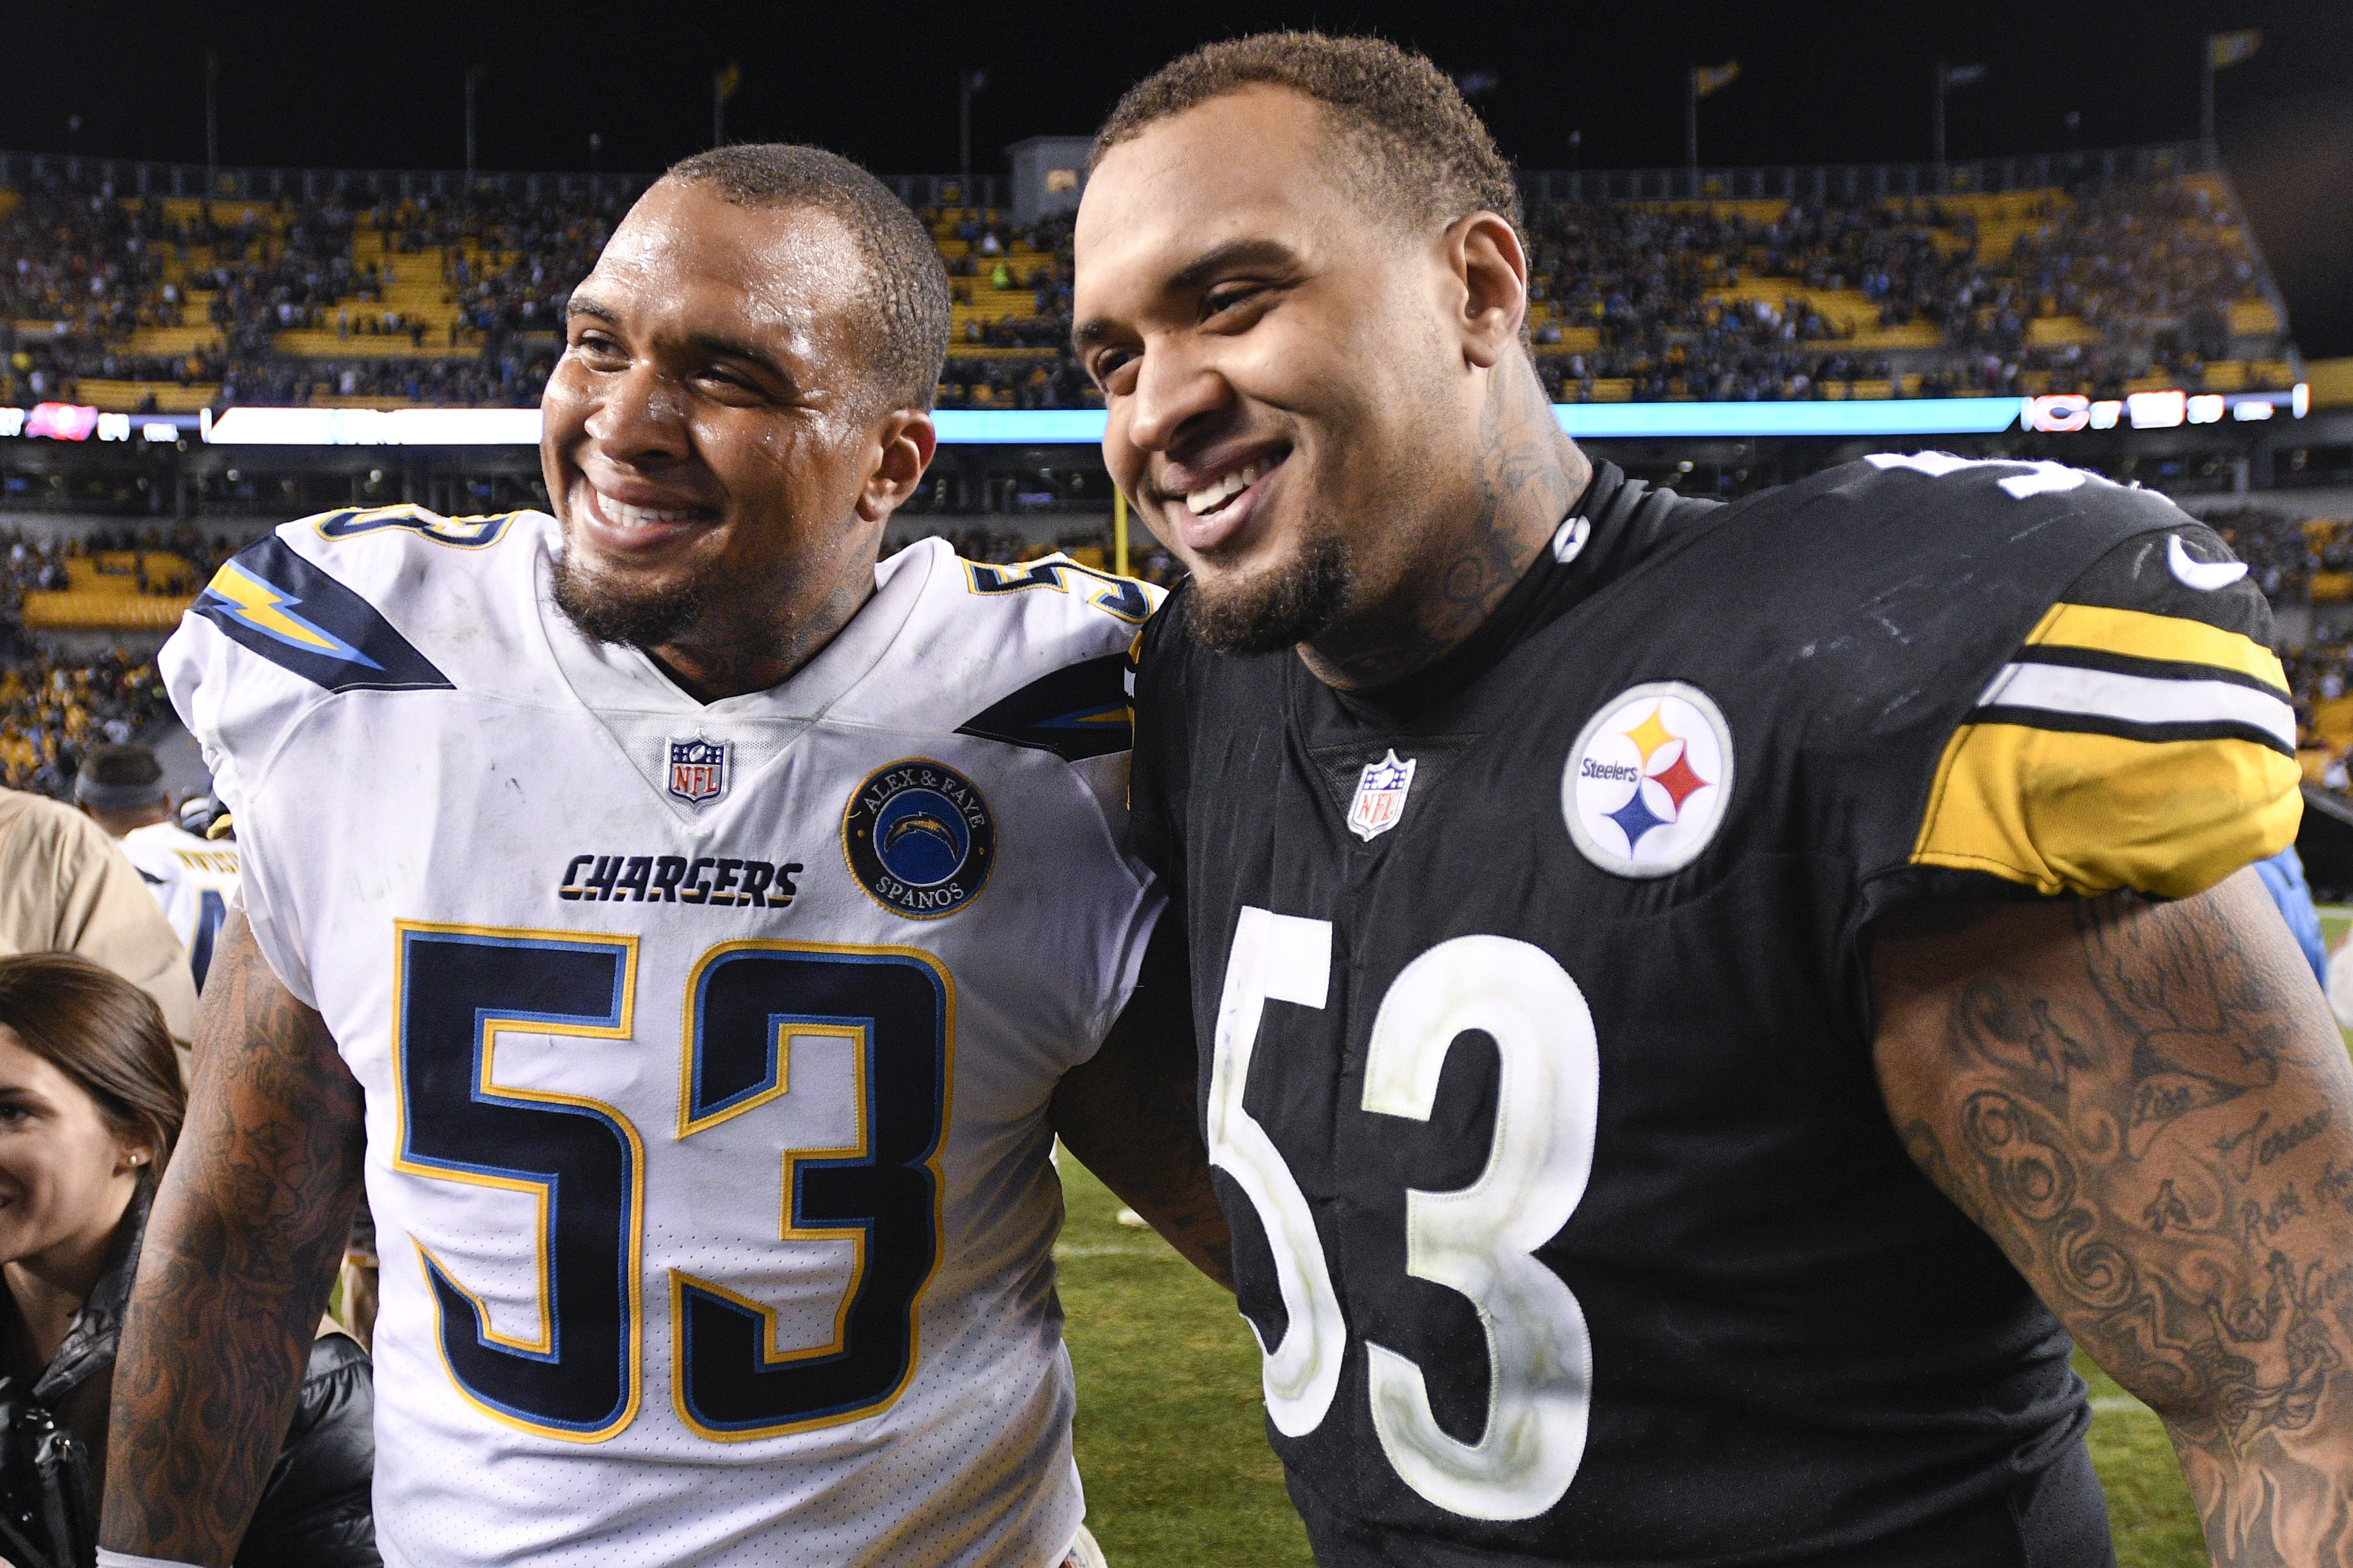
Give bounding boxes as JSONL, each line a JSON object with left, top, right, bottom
{"left": 0, "top": 954, "right": 188, "bottom": 1184}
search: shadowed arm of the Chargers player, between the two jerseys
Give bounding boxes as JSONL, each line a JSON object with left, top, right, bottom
{"left": 1047, "top": 911, "right": 1233, "bottom": 1290}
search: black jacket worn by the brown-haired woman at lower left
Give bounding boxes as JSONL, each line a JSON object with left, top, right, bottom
{"left": 0, "top": 1194, "right": 384, "bottom": 1568}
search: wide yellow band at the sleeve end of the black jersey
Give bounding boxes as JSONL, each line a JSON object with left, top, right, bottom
{"left": 1911, "top": 715, "right": 2304, "bottom": 897}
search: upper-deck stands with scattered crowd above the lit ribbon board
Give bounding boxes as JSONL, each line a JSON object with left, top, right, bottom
{"left": 0, "top": 167, "right": 2261, "bottom": 409}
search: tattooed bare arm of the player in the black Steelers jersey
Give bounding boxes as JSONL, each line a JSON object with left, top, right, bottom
{"left": 1870, "top": 871, "right": 2353, "bottom": 1568}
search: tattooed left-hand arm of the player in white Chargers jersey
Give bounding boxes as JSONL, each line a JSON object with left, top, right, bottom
{"left": 99, "top": 914, "right": 362, "bottom": 1563}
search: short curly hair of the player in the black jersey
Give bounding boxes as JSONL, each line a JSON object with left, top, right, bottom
{"left": 1087, "top": 33, "right": 1520, "bottom": 228}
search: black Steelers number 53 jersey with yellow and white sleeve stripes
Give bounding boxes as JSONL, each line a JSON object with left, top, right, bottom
{"left": 1134, "top": 454, "right": 2299, "bottom": 1568}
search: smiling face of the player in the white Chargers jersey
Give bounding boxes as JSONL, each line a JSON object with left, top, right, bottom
{"left": 541, "top": 179, "right": 932, "bottom": 697}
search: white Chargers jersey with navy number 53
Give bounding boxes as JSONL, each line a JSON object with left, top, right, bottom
{"left": 162, "top": 506, "right": 1162, "bottom": 1568}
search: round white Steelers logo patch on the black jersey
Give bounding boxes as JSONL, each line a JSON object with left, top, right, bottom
{"left": 1560, "top": 680, "right": 1732, "bottom": 876}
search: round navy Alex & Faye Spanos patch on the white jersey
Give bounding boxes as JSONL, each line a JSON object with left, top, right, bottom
{"left": 842, "top": 756, "right": 998, "bottom": 920}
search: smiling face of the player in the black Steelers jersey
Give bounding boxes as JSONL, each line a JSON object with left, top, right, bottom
{"left": 1076, "top": 85, "right": 1485, "bottom": 652}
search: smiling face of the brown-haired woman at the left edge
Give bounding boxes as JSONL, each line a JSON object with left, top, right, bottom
{"left": 0, "top": 1024, "right": 155, "bottom": 1274}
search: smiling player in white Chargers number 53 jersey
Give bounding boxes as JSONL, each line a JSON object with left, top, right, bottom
{"left": 101, "top": 146, "right": 1226, "bottom": 1568}
